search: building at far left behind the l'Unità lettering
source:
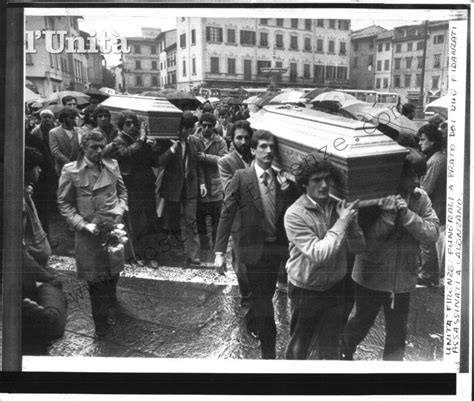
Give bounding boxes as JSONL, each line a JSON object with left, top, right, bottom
{"left": 25, "top": 16, "right": 89, "bottom": 96}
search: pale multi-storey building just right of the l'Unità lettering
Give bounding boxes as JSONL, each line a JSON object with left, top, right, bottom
{"left": 121, "top": 28, "right": 161, "bottom": 93}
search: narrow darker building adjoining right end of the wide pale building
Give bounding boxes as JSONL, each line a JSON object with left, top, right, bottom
{"left": 350, "top": 25, "right": 387, "bottom": 89}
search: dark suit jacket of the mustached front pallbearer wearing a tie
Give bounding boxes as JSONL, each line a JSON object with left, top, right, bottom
{"left": 215, "top": 165, "right": 296, "bottom": 264}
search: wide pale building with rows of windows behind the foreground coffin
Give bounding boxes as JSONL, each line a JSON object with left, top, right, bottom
{"left": 176, "top": 17, "right": 350, "bottom": 90}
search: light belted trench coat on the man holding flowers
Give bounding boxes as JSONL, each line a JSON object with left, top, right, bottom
{"left": 58, "top": 157, "right": 128, "bottom": 281}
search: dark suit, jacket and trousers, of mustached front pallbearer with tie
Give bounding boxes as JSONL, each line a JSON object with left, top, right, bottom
{"left": 215, "top": 165, "right": 294, "bottom": 359}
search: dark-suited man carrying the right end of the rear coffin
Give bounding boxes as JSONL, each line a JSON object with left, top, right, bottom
{"left": 158, "top": 111, "right": 207, "bottom": 265}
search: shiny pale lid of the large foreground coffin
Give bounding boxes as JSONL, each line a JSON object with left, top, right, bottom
{"left": 248, "top": 105, "right": 407, "bottom": 159}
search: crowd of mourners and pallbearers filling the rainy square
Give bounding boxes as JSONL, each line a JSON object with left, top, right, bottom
{"left": 23, "top": 94, "right": 446, "bottom": 360}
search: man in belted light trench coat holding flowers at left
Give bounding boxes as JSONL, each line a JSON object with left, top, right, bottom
{"left": 58, "top": 132, "right": 128, "bottom": 337}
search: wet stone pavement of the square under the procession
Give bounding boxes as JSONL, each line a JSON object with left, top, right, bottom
{"left": 15, "top": 211, "right": 444, "bottom": 361}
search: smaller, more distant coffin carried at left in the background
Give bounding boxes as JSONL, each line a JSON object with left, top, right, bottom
{"left": 101, "top": 95, "right": 183, "bottom": 138}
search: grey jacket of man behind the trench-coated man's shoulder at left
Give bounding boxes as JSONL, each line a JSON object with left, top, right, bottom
{"left": 49, "top": 126, "right": 81, "bottom": 175}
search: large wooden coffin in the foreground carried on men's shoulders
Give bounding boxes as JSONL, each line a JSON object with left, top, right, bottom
{"left": 249, "top": 105, "right": 408, "bottom": 205}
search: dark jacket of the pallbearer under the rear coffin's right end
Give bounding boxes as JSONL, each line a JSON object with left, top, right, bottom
{"left": 158, "top": 135, "right": 204, "bottom": 202}
